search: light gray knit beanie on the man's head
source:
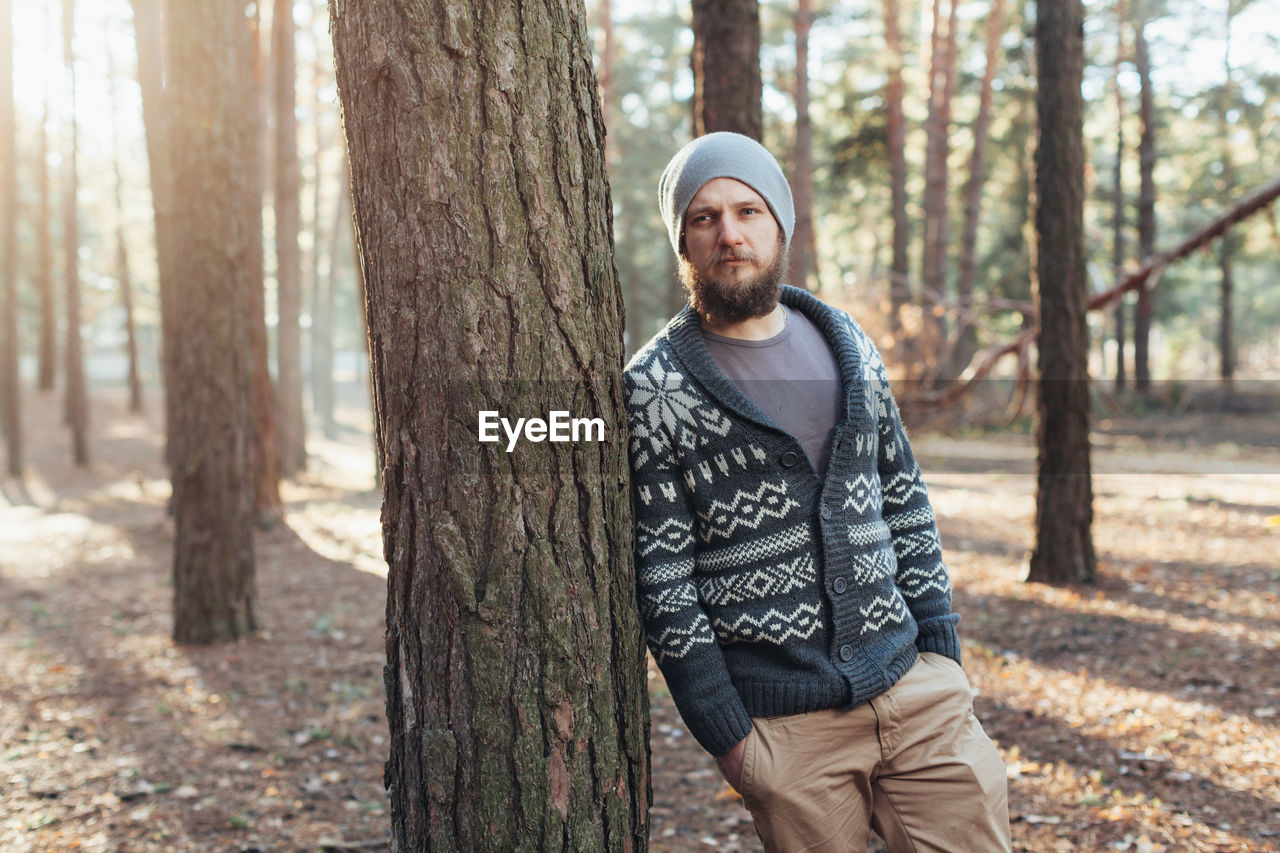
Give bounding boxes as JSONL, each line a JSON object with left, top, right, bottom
{"left": 658, "top": 132, "right": 796, "bottom": 255}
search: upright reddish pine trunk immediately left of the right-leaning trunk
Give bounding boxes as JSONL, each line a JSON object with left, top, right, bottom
{"left": 920, "top": 0, "right": 960, "bottom": 358}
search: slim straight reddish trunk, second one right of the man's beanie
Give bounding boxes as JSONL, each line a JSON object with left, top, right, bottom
{"left": 884, "top": 0, "right": 911, "bottom": 337}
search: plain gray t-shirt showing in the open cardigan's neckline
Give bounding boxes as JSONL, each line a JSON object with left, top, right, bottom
{"left": 701, "top": 305, "right": 845, "bottom": 480}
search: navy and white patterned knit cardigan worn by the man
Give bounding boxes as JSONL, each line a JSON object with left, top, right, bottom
{"left": 623, "top": 287, "right": 960, "bottom": 756}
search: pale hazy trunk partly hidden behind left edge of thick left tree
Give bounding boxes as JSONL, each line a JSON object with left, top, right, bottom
{"left": 132, "top": 0, "right": 182, "bottom": 464}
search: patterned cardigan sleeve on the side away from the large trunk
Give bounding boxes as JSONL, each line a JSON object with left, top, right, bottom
{"left": 868, "top": 348, "right": 960, "bottom": 663}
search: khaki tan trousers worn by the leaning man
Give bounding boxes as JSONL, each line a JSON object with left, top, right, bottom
{"left": 740, "top": 652, "right": 1010, "bottom": 853}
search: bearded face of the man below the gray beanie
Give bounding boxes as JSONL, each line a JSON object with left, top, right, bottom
{"left": 680, "top": 178, "right": 787, "bottom": 323}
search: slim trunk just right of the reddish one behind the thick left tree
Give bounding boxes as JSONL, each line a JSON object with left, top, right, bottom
{"left": 271, "top": 0, "right": 307, "bottom": 476}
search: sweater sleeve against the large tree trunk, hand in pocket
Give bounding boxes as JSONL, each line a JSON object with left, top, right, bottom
{"left": 626, "top": 363, "right": 751, "bottom": 756}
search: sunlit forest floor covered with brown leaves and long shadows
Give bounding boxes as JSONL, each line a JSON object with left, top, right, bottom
{"left": 0, "top": 393, "right": 1280, "bottom": 853}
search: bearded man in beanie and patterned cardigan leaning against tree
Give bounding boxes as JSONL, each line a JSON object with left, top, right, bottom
{"left": 625, "top": 133, "right": 1010, "bottom": 853}
